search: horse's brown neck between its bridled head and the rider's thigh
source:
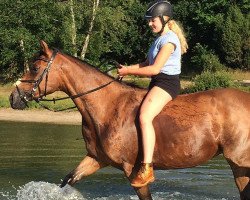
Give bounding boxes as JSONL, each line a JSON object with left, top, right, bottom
{"left": 60, "top": 55, "right": 144, "bottom": 124}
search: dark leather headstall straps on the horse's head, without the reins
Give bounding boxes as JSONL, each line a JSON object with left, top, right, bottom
{"left": 16, "top": 49, "right": 58, "bottom": 106}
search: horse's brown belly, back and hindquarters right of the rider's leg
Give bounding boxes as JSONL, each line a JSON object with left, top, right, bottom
{"left": 154, "top": 89, "right": 250, "bottom": 168}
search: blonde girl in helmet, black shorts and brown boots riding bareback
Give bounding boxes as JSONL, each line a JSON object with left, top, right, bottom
{"left": 118, "top": 0, "right": 188, "bottom": 187}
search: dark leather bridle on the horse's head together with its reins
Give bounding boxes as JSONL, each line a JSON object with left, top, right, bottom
{"left": 16, "top": 49, "right": 122, "bottom": 112}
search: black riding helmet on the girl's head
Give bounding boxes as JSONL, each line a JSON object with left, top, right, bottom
{"left": 145, "top": 0, "right": 173, "bottom": 19}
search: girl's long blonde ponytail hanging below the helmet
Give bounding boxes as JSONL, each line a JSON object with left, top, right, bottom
{"left": 168, "top": 20, "right": 188, "bottom": 54}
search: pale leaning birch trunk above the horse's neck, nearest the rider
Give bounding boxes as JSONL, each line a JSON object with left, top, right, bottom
{"left": 81, "top": 0, "right": 100, "bottom": 60}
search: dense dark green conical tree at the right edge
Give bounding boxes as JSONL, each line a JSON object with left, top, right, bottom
{"left": 216, "top": 6, "right": 250, "bottom": 70}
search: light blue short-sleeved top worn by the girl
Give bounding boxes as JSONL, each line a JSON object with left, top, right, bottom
{"left": 148, "top": 31, "right": 181, "bottom": 75}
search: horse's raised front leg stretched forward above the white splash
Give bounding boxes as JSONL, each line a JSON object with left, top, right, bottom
{"left": 60, "top": 156, "right": 107, "bottom": 187}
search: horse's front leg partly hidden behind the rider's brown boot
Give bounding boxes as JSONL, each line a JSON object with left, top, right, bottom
{"left": 123, "top": 162, "right": 152, "bottom": 200}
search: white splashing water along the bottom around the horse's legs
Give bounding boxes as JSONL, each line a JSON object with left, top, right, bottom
{"left": 0, "top": 181, "right": 234, "bottom": 200}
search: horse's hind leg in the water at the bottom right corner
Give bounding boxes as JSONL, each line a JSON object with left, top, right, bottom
{"left": 229, "top": 162, "right": 250, "bottom": 200}
